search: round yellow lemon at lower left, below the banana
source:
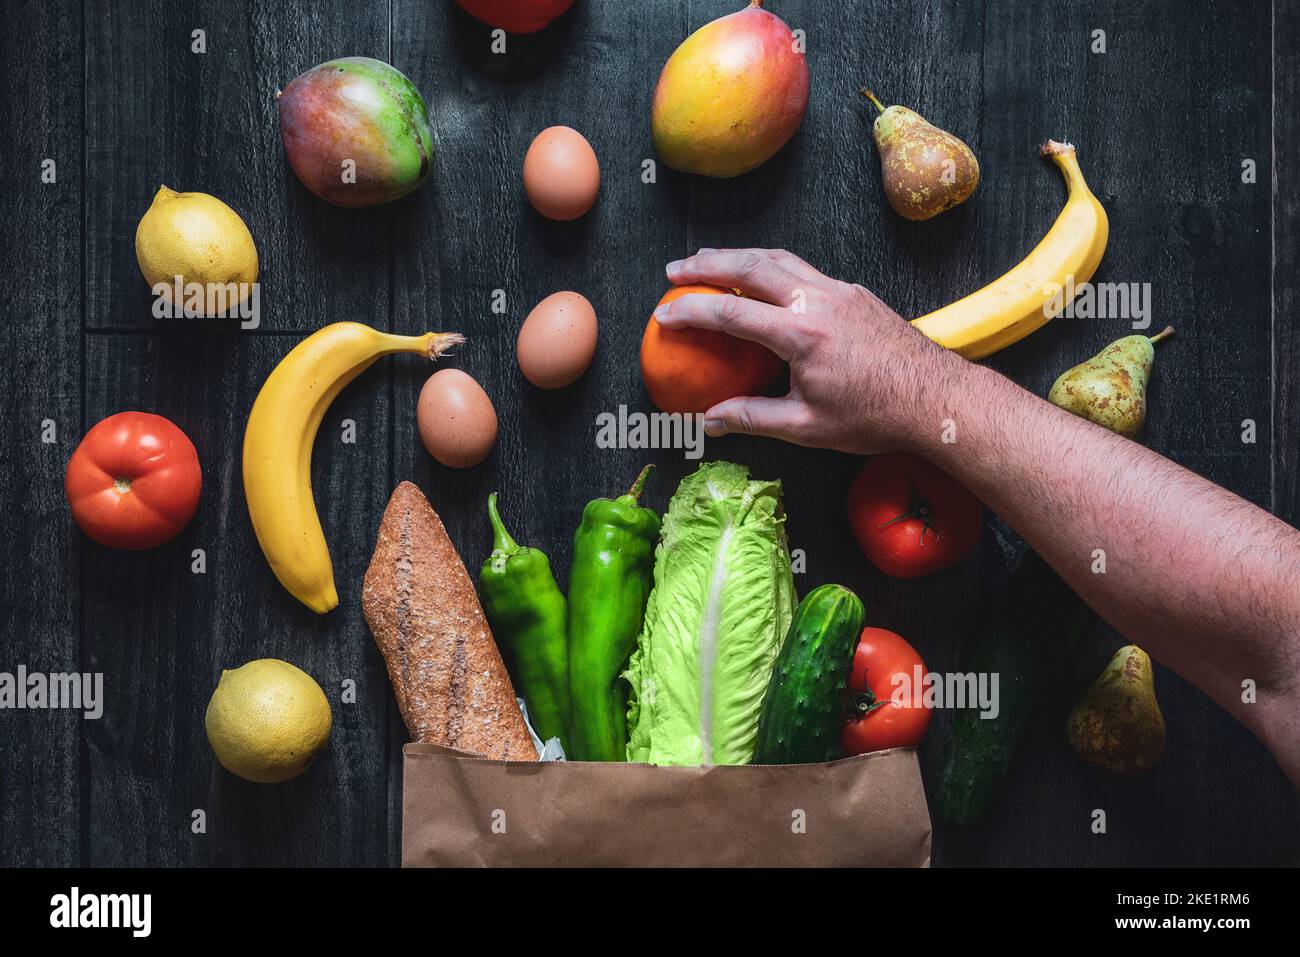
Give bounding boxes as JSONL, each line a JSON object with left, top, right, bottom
{"left": 203, "top": 658, "right": 334, "bottom": 784}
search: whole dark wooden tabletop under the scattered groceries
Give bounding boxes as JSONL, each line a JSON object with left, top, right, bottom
{"left": 0, "top": 0, "right": 1300, "bottom": 865}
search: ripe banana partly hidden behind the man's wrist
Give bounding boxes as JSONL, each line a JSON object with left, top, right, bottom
{"left": 913, "top": 139, "right": 1110, "bottom": 359}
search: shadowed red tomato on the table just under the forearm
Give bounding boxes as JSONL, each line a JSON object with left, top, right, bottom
{"left": 849, "top": 452, "right": 984, "bottom": 579}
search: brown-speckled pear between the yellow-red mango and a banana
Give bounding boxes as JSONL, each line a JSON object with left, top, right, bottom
{"left": 861, "top": 90, "right": 979, "bottom": 220}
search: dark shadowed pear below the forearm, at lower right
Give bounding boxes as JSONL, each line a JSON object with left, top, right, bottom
{"left": 1067, "top": 645, "right": 1165, "bottom": 774}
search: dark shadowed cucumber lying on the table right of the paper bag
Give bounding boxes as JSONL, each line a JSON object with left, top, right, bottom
{"left": 935, "top": 538, "right": 1089, "bottom": 827}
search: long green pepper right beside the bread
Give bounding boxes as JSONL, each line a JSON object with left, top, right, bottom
{"left": 478, "top": 492, "right": 569, "bottom": 754}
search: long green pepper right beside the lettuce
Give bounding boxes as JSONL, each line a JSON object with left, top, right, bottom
{"left": 566, "top": 465, "right": 659, "bottom": 761}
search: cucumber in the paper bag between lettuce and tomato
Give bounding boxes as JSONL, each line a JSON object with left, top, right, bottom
{"left": 754, "top": 585, "right": 866, "bottom": 765}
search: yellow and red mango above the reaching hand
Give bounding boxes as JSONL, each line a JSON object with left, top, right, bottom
{"left": 650, "top": 0, "right": 809, "bottom": 178}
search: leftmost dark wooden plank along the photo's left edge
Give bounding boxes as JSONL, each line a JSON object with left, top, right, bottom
{"left": 0, "top": 3, "right": 87, "bottom": 867}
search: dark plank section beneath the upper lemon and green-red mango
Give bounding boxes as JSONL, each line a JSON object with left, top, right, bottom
{"left": 86, "top": 0, "right": 393, "bottom": 332}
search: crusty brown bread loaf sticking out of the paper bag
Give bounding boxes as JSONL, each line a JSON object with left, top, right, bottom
{"left": 361, "top": 482, "right": 537, "bottom": 761}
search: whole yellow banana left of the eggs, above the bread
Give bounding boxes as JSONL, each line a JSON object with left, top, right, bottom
{"left": 243, "top": 322, "right": 465, "bottom": 614}
